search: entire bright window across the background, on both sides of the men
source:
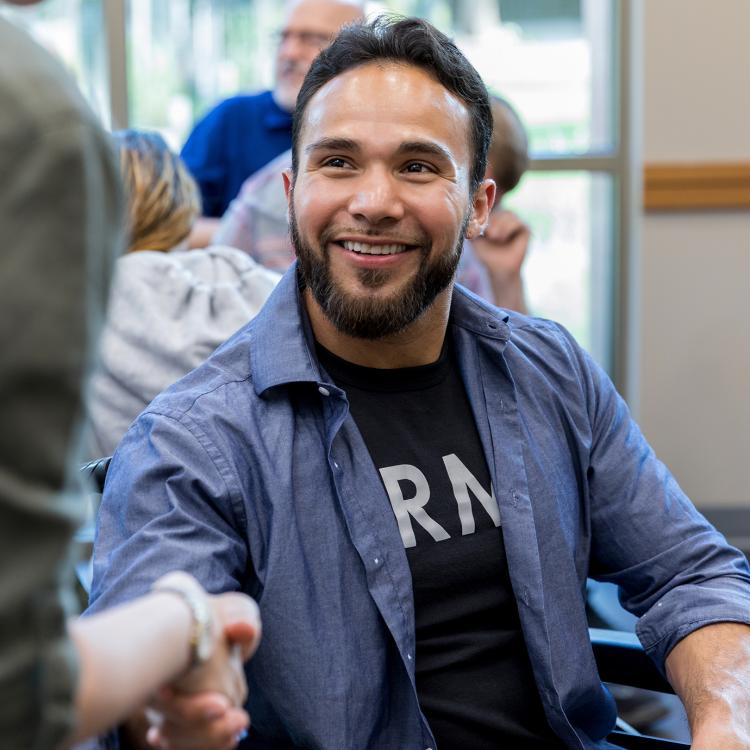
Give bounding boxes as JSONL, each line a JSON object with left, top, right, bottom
{"left": 5, "top": 0, "right": 628, "bottom": 380}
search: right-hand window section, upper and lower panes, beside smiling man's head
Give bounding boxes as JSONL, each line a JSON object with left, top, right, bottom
{"left": 378, "top": 0, "right": 622, "bottom": 372}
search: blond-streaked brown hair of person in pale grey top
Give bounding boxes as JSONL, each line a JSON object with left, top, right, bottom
{"left": 114, "top": 130, "right": 201, "bottom": 252}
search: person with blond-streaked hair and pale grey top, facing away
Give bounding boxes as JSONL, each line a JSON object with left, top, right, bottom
{"left": 86, "top": 130, "right": 280, "bottom": 458}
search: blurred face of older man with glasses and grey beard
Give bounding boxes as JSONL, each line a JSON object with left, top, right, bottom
{"left": 273, "top": 0, "right": 362, "bottom": 112}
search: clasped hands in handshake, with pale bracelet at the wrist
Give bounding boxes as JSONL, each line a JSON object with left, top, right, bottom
{"left": 140, "top": 572, "right": 261, "bottom": 750}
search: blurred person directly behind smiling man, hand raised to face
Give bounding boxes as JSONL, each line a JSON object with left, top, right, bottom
{"left": 214, "top": 97, "right": 530, "bottom": 313}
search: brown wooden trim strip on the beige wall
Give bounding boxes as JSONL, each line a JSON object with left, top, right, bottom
{"left": 643, "top": 162, "right": 750, "bottom": 211}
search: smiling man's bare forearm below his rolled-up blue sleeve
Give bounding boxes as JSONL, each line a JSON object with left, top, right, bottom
{"left": 666, "top": 623, "right": 750, "bottom": 750}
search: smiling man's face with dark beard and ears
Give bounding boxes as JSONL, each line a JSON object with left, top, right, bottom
{"left": 285, "top": 63, "right": 493, "bottom": 339}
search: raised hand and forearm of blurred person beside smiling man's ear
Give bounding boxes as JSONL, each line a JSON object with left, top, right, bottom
{"left": 472, "top": 210, "right": 531, "bottom": 313}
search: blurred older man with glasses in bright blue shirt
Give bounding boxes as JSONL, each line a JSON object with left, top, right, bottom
{"left": 187, "top": 0, "right": 363, "bottom": 247}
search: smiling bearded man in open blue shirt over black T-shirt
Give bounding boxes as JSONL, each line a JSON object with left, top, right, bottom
{"left": 88, "top": 13, "right": 750, "bottom": 750}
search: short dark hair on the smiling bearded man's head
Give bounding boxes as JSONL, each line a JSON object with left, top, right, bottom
{"left": 292, "top": 15, "right": 492, "bottom": 193}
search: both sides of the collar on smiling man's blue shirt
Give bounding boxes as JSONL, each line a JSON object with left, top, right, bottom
{"left": 249, "top": 262, "right": 510, "bottom": 395}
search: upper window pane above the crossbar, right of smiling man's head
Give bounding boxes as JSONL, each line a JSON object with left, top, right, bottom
{"left": 378, "top": 0, "right": 617, "bottom": 156}
